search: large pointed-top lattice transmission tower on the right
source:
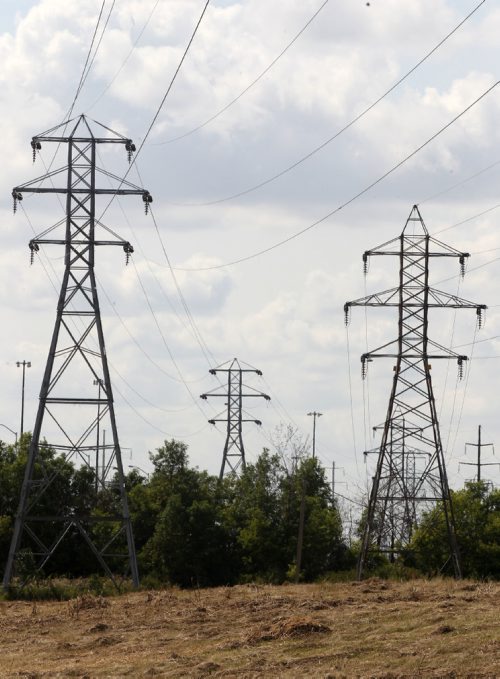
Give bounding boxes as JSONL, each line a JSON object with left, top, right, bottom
{"left": 344, "top": 205, "right": 486, "bottom": 578}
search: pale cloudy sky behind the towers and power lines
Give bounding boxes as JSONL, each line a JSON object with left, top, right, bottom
{"left": 0, "top": 0, "right": 500, "bottom": 510}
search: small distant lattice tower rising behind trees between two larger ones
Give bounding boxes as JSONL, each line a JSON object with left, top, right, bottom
{"left": 200, "top": 358, "right": 271, "bottom": 479}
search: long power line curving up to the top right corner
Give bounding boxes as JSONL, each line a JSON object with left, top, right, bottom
{"left": 166, "top": 0, "right": 486, "bottom": 207}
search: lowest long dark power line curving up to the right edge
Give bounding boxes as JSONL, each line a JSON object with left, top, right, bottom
{"left": 170, "top": 80, "right": 500, "bottom": 271}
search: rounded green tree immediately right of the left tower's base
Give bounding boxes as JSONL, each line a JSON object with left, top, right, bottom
{"left": 137, "top": 440, "right": 235, "bottom": 586}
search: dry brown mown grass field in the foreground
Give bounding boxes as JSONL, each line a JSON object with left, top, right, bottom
{"left": 0, "top": 579, "right": 500, "bottom": 679}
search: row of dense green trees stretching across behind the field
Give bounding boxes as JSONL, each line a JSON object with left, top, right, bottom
{"left": 0, "top": 434, "right": 500, "bottom": 587}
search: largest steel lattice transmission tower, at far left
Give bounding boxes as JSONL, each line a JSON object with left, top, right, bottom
{"left": 3, "top": 115, "right": 152, "bottom": 588}
